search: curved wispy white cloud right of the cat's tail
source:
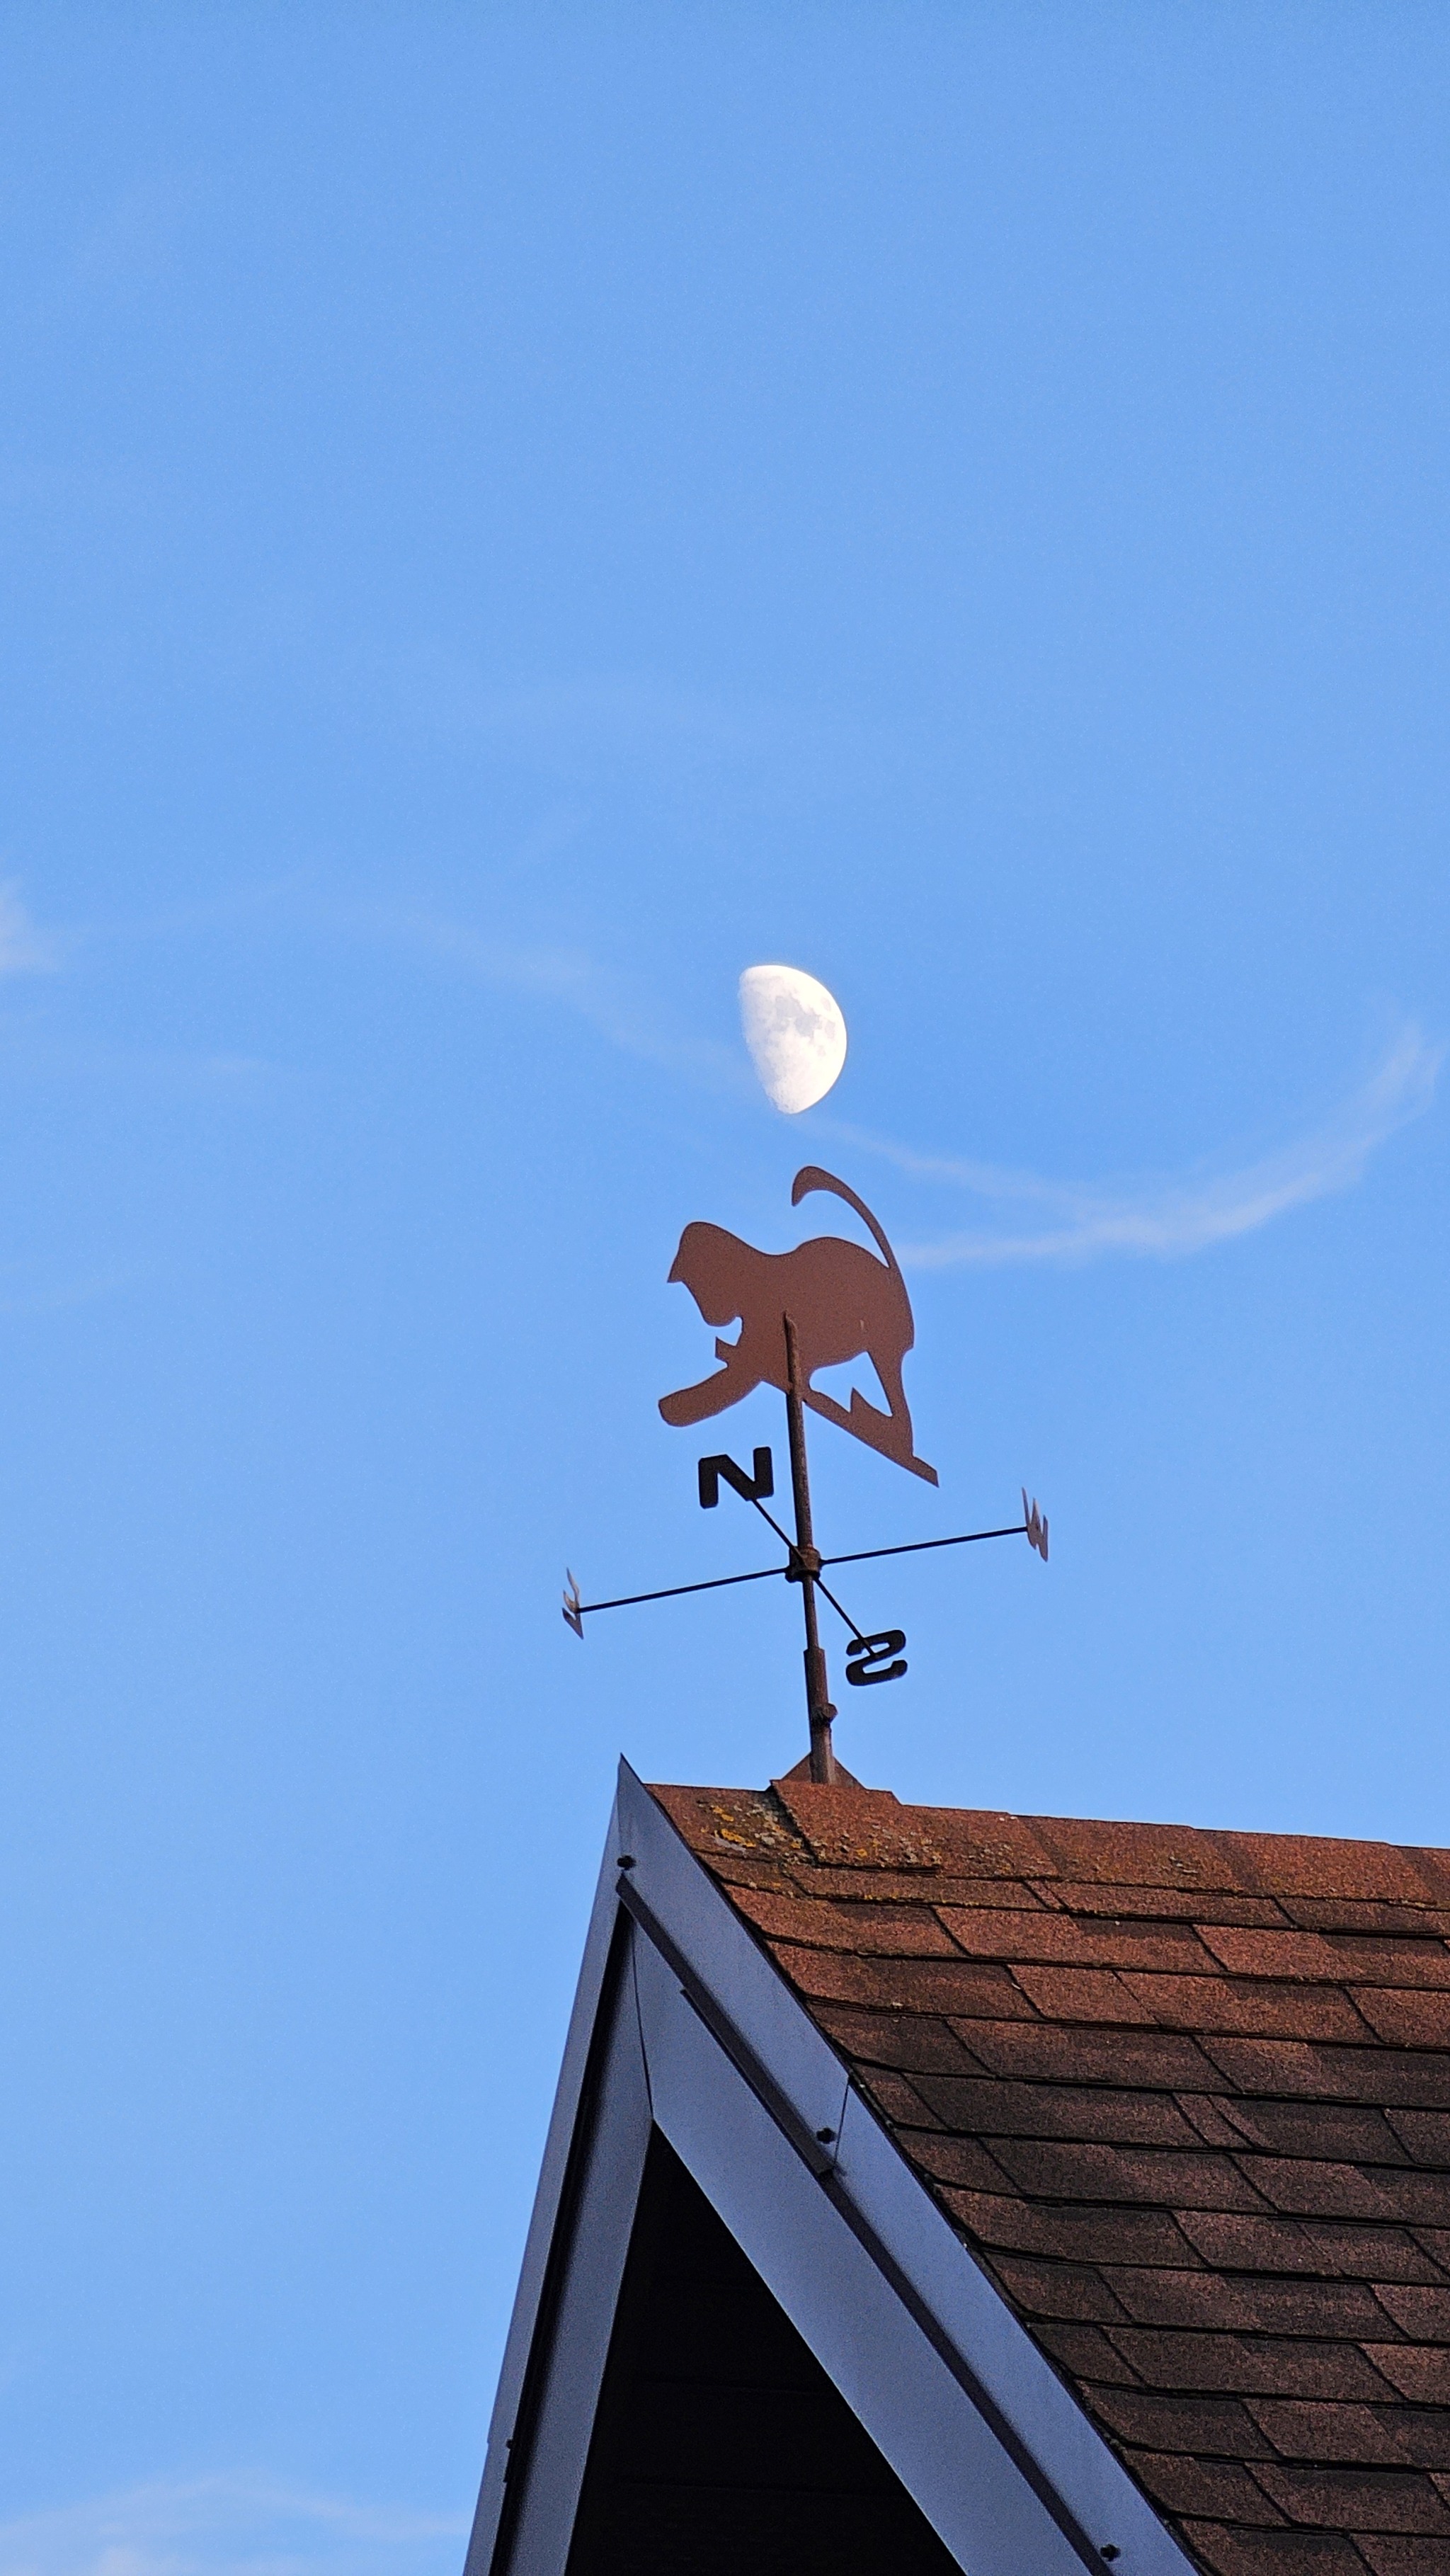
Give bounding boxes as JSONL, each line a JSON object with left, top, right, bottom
{"left": 850, "top": 1025, "right": 1445, "bottom": 1270}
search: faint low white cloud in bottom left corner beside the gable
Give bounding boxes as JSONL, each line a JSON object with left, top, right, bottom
{"left": 0, "top": 2475, "right": 466, "bottom": 2576}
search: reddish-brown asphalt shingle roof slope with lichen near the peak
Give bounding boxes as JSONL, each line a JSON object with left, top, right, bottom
{"left": 654, "top": 1780, "right": 1450, "bottom": 2576}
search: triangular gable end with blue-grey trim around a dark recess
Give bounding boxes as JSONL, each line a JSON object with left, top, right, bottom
{"left": 469, "top": 1762, "right": 1174, "bottom": 2576}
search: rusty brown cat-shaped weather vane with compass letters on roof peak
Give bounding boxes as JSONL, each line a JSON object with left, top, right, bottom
{"left": 564, "top": 1162, "right": 1049, "bottom": 1780}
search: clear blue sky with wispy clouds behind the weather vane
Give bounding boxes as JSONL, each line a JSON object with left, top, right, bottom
{"left": 0, "top": 0, "right": 1450, "bottom": 2576}
